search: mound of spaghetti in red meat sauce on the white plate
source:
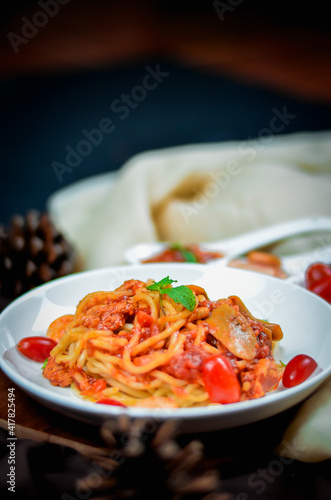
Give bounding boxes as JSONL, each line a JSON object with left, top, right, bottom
{"left": 43, "top": 279, "right": 282, "bottom": 408}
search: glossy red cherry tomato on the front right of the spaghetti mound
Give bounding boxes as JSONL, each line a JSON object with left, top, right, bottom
{"left": 202, "top": 354, "right": 240, "bottom": 404}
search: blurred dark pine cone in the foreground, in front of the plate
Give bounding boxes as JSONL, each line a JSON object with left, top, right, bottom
{"left": 77, "top": 415, "right": 231, "bottom": 500}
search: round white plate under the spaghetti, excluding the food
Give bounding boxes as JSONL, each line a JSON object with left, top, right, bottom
{"left": 0, "top": 264, "right": 331, "bottom": 432}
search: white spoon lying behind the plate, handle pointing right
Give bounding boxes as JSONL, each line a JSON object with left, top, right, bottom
{"left": 125, "top": 216, "right": 331, "bottom": 264}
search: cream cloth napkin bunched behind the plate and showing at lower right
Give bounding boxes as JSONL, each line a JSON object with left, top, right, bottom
{"left": 49, "top": 131, "right": 331, "bottom": 461}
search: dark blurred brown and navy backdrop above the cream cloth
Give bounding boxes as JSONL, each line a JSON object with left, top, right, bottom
{"left": 0, "top": 0, "right": 331, "bottom": 223}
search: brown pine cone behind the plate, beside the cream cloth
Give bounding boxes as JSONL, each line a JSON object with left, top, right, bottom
{"left": 0, "top": 210, "right": 76, "bottom": 301}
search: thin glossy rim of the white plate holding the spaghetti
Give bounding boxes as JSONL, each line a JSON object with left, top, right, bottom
{"left": 0, "top": 263, "right": 331, "bottom": 428}
